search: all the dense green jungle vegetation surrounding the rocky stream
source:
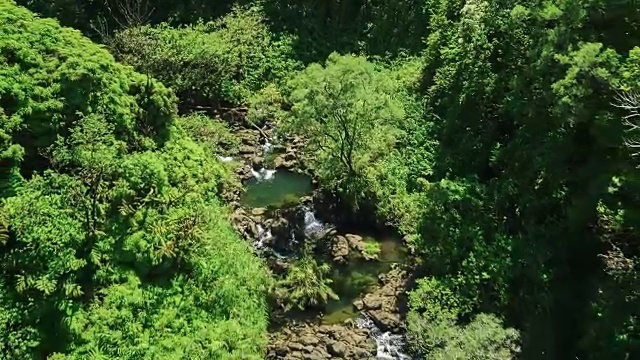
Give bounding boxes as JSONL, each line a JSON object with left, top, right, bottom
{"left": 0, "top": 0, "right": 640, "bottom": 360}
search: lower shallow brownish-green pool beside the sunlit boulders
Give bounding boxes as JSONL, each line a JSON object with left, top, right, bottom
{"left": 322, "top": 237, "right": 407, "bottom": 324}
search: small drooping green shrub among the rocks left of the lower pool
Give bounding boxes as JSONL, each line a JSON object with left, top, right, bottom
{"left": 275, "top": 255, "right": 338, "bottom": 310}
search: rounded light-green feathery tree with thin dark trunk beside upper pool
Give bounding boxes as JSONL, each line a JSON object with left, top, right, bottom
{"left": 283, "top": 53, "right": 404, "bottom": 204}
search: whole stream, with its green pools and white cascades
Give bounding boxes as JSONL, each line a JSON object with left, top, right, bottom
{"left": 230, "top": 126, "right": 410, "bottom": 360}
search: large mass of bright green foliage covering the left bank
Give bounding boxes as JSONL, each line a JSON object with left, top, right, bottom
{"left": 0, "top": 2, "right": 270, "bottom": 359}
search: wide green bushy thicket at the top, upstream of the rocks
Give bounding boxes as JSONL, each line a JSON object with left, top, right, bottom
{"left": 110, "top": 7, "right": 295, "bottom": 109}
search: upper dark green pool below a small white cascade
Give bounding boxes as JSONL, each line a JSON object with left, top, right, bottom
{"left": 241, "top": 170, "right": 313, "bottom": 208}
